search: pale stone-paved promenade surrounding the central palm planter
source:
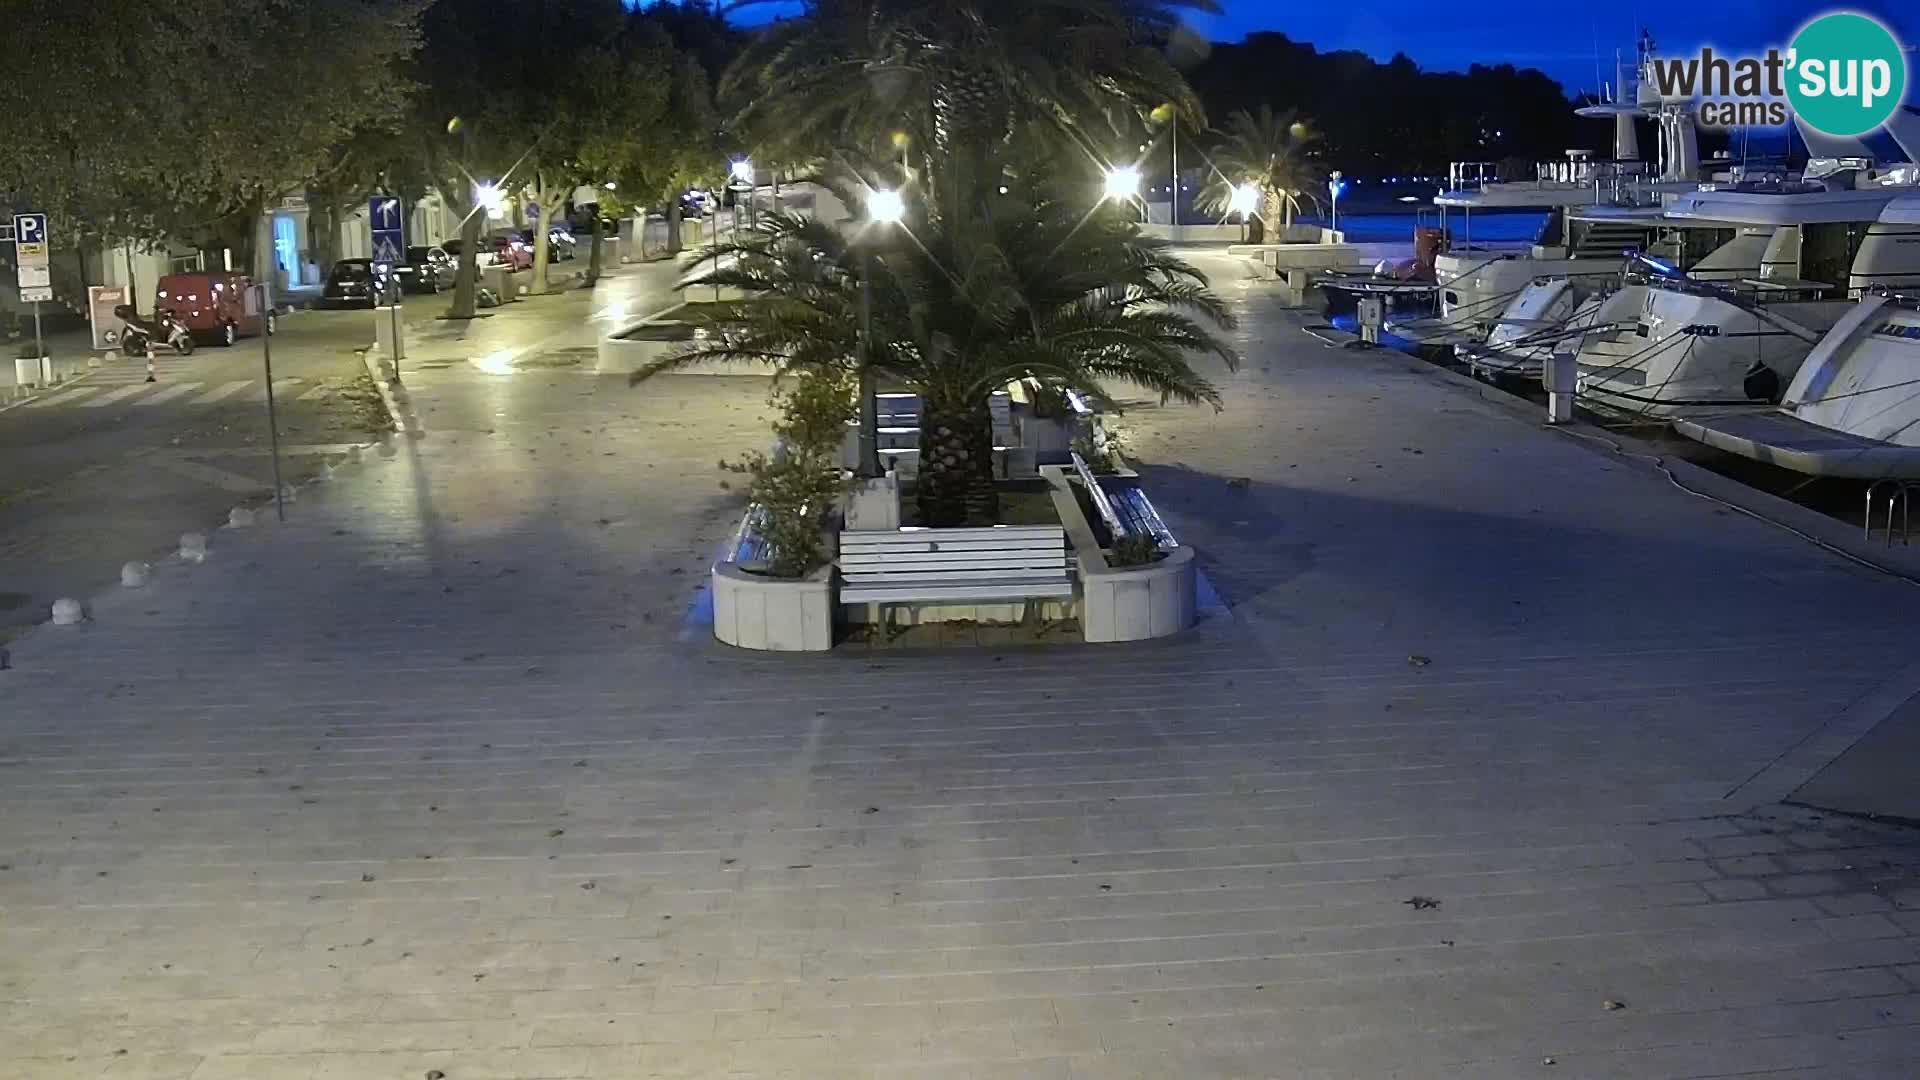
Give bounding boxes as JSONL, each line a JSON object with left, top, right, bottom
{"left": 0, "top": 253, "right": 1920, "bottom": 1080}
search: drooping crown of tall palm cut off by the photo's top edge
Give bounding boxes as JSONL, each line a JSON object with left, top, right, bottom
{"left": 722, "top": 0, "right": 1219, "bottom": 176}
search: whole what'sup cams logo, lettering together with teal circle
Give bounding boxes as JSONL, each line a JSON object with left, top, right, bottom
{"left": 1651, "top": 12, "right": 1907, "bottom": 135}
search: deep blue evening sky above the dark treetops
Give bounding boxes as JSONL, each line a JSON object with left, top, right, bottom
{"left": 725, "top": 0, "right": 1920, "bottom": 100}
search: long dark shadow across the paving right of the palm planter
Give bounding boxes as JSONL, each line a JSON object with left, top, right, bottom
{"left": 1140, "top": 457, "right": 1912, "bottom": 636}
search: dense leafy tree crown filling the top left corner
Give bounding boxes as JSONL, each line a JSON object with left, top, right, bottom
{"left": 0, "top": 0, "right": 422, "bottom": 272}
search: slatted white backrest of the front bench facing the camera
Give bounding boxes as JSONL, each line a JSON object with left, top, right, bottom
{"left": 839, "top": 525, "right": 1068, "bottom": 582}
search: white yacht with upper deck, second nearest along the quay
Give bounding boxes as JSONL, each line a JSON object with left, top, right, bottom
{"left": 1578, "top": 160, "right": 1920, "bottom": 419}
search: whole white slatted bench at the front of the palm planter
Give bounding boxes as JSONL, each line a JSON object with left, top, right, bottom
{"left": 839, "top": 525, "right": 1073, "bottom": 623}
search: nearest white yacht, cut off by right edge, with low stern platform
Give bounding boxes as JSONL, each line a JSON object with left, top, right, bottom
{"left": 1674, "top": 194, "right": 1920, "bottom": 480}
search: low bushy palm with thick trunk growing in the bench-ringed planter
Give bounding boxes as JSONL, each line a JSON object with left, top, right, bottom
{"left": 634, "top": 167, "right": 1238, "bottom": 527}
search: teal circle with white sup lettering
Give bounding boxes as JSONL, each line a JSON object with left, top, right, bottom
{"left": 1788, "top": 12, "right": 1907, "bottom": 135}
